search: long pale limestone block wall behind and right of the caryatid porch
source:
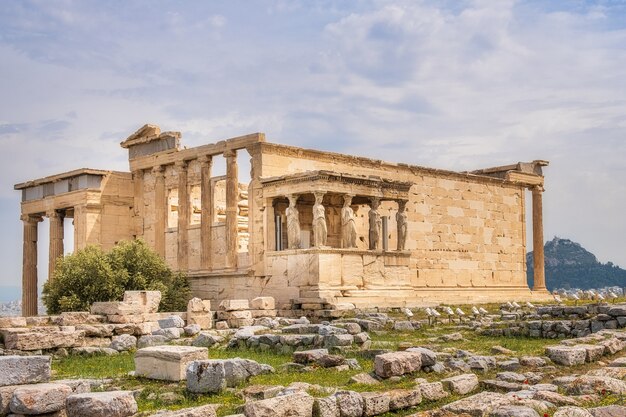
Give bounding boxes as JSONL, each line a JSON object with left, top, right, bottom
{"left": 258, "top": 143, "right": 530, "bottom": 299}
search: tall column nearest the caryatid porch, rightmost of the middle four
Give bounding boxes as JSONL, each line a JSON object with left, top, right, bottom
{"left": 224, "top": 149, "right": 239, "bottom": 269}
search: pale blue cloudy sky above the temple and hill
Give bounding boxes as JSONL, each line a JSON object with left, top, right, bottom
{"left": 0, "top": 0, "right": 626, "bottom": 292}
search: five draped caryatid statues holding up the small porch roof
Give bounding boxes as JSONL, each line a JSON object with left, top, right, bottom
{"left": 285, "top": 191, "right": 408, "bottom": 251}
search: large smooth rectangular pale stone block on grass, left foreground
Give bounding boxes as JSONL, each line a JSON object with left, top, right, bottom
{"left": 135, "top": 346, "right": 209, "bottom": 381}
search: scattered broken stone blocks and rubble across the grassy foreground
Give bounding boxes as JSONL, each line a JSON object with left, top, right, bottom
{"left": 6, "top": 292, "right": 626, "bottom": 417}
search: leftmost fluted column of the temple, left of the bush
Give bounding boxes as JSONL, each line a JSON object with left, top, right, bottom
{"left": 21, "top": 216, "right": 41, "bottom": 317}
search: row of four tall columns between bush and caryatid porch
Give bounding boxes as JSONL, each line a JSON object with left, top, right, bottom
{"left": 143, "top": 150, "right": 239, "bottom": 271}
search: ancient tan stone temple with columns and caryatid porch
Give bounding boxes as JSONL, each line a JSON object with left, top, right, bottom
{"left": 15, "top": 125, "right": 548, "bottom": 315}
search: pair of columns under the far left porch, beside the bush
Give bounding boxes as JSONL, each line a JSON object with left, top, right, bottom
{"left": 21, "top": 210, "right": 65, "bottom": 317}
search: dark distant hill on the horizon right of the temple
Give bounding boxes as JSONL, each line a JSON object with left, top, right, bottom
{"left": 526, "top": 237, "right": 626, "bottom": 290}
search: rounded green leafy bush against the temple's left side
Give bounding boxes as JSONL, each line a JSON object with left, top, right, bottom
{"left": 43, "top": 240, "right": 191, "bottom": 314}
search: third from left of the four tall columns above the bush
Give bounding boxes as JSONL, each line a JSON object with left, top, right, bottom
{"left": 198, "top": 155, "right": 213, "bottom": 270}
